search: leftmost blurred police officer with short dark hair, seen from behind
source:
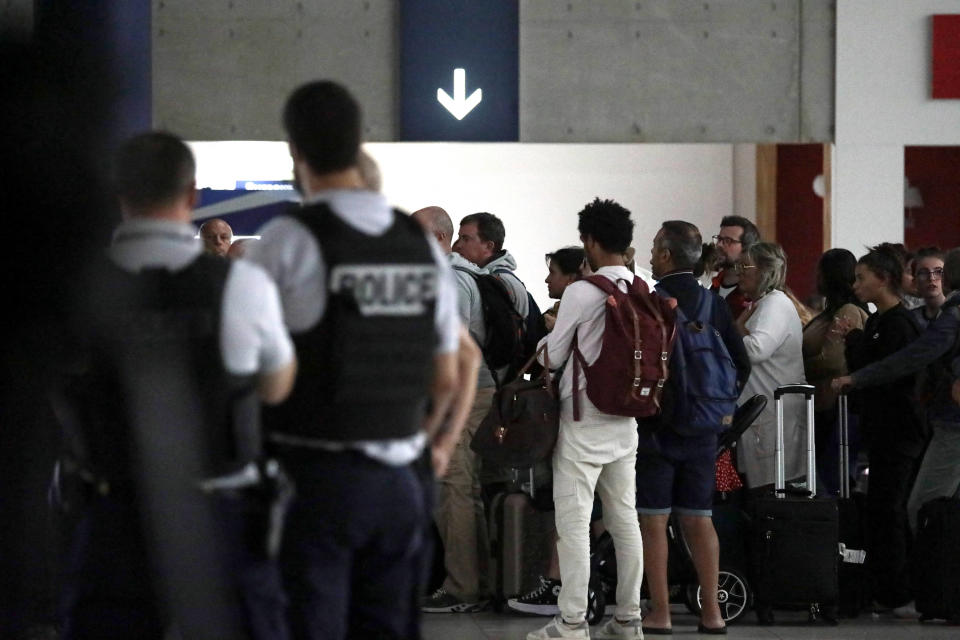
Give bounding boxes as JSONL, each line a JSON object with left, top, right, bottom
{"left": 58, "top": 133, "right": 296, "bottom": 640}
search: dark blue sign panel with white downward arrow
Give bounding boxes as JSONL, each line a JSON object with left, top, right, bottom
{"left": 400, "top": 0, "right": 520, "bottom": 142}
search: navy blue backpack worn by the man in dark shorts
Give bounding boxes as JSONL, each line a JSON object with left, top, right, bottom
{"left": 657, "top": 287, "right": 739, "bottom": 435}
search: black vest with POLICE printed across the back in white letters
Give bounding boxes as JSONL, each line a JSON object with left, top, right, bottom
{"left": 269, "top": 204, "right": 439, "bottom": 442}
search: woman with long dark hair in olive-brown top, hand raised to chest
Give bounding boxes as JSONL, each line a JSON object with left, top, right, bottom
{"left": 803, "top": 249, "right": 867, "bottom": 493}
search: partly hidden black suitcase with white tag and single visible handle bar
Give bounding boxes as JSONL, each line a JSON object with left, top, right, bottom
{"left": 837, "top": 393, "right": 867, "bottom": 618}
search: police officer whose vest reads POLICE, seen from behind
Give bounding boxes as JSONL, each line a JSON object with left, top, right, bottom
{"left": 247, "top": 81, "right": 459, "bottom": 640}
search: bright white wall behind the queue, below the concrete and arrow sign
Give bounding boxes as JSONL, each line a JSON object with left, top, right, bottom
{"left": 192, "top": 142, "right": 740, "bottom": 306}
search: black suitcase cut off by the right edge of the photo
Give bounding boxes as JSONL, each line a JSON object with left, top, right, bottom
{"left": 913, "top": 498, "right": 960, "bottom": 623}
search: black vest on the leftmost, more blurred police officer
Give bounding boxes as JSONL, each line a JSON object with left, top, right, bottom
{"left": 79, "top": 255, "right": 261, "bottom": 490}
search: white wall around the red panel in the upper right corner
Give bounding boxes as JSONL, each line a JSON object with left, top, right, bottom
{"left": 832, "top": 0, "right": 960, "bottom": 255}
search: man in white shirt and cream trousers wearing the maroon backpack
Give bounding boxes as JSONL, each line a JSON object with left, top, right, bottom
{"left": 527, "top": 199, "right": 643, "bottom": 640}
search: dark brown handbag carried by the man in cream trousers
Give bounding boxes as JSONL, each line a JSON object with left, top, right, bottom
{"left": 470, "top": 345, "right": 560, "bottom": 467}
